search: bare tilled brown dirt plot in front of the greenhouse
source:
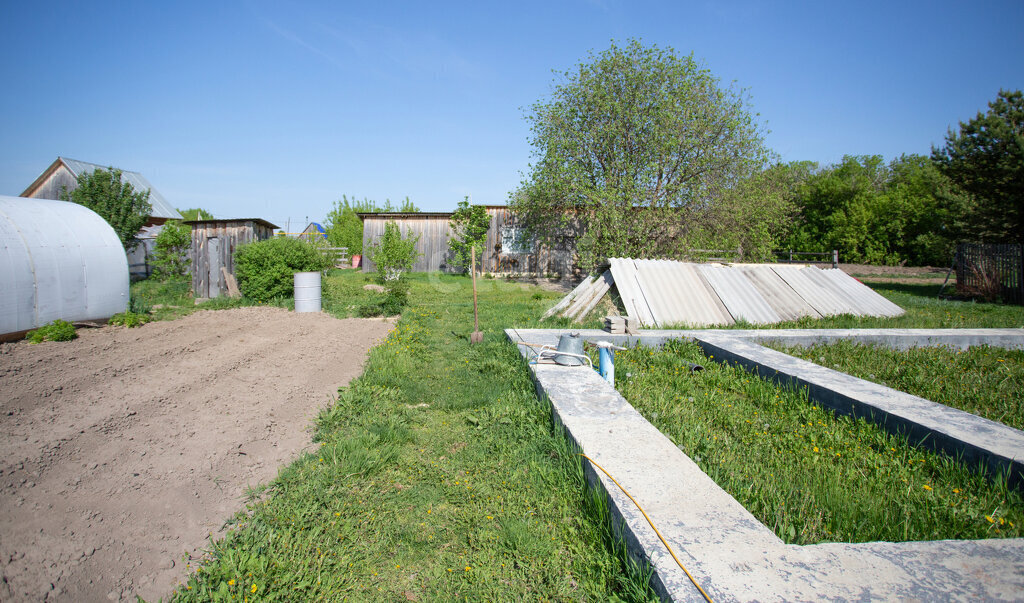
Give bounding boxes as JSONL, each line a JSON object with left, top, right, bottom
{"left": 0, "top": 307, "right": 392, "bottom": 601}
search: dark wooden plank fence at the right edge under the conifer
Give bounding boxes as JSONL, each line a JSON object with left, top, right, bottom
{"left": 955, "top": 243, "right": 1024, "bottom": 304}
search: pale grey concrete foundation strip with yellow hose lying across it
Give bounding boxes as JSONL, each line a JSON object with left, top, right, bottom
{"left": 506, "top": 329, "right": 1024, "bottom": 601}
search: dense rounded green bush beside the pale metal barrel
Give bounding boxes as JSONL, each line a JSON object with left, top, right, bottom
{"left": 234, "top": 236, "right": 331, "bottom": 302}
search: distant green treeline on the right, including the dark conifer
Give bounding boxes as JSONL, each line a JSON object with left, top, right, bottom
{"left": 716, "top": 90, "right": 1024, "bottom": 265}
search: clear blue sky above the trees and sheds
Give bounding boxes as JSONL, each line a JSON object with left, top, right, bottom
{"left": 0, "top": 0, "right": 1024, "bottom": 230}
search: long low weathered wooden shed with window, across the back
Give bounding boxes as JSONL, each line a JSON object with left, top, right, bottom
{"left": 358, "top": 205, "right": 575, "bottom": 274}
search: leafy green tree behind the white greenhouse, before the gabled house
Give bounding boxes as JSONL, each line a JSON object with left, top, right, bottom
{"left": 60, "top": 168, "right": 153, "bottom": 251}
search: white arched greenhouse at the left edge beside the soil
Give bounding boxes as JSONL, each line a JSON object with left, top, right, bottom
{"left": 0, "top": 196, "right": 128, "bottom": 339}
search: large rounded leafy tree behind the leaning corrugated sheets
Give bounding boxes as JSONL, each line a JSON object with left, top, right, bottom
{"left": 511, "top": 40, "right": 769, "bottom": 267}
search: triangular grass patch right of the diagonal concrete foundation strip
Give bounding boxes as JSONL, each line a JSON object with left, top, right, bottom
{"left": 769, "top": 340, "right": 1024, "bottom": 429}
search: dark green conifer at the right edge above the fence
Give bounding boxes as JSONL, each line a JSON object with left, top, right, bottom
{"left": 932, "top": 90, "right": 1024, "bottom": 243}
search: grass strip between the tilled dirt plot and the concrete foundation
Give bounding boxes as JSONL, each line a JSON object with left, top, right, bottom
{"left": 164, "top": 271, "right": 652, "bottom": 601}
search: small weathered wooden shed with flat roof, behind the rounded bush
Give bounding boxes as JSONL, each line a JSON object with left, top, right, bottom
{"left": 184, "top": 218, "right": 280, "bottom": 297}
